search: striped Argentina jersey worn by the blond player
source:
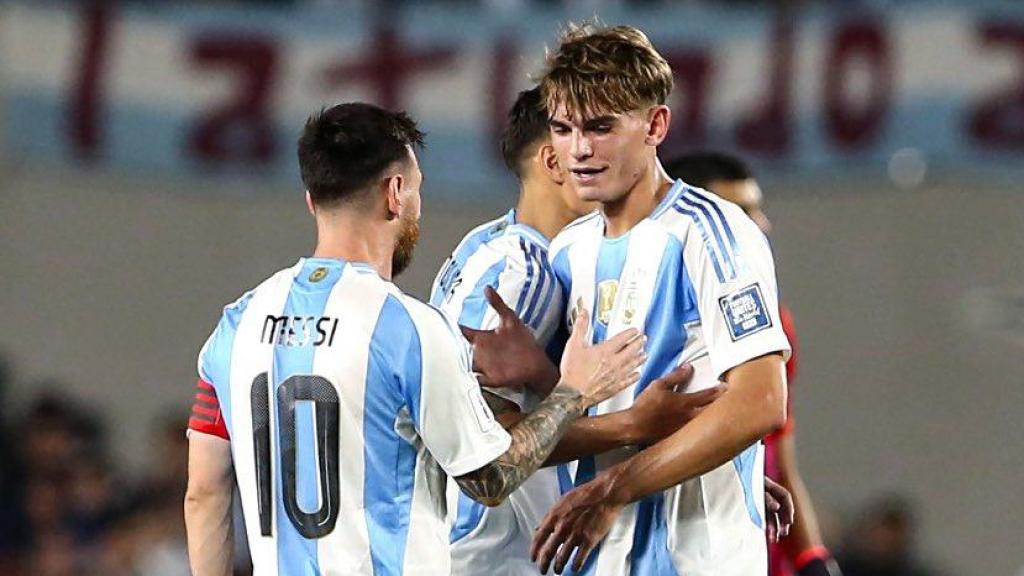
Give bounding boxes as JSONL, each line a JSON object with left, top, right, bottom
{"left": 551, "top": 180, "right": 790, "bottom": 576}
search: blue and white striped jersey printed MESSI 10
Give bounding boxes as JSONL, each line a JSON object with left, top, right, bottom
{"left": 199, "top": 258, "right": 511, "bottom": 576}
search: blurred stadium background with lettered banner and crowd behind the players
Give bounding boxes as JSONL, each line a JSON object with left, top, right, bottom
{"left": 0, "top": 0, "right": 1024, "bottom": 576}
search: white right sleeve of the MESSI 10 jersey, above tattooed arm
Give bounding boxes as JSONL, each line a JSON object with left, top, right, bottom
{"left": 404, "top": 313, "right": 512, "bottom": 477}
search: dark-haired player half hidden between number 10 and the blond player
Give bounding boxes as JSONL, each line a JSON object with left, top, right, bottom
{"left": 430, "top": 87, "right": 721, "bottom": 576}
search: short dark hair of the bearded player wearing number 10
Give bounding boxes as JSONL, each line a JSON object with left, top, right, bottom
{"left": 299, "top": 102, "right": 423, "bottom": 205}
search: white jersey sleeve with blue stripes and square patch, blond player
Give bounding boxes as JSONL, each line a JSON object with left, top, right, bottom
{"left": 684, "top": 196, "right": 790, "bottom": 377}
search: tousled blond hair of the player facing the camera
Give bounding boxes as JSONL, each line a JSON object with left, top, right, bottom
{"left": 539, "top": 24, "right": 673, "bottom": 117}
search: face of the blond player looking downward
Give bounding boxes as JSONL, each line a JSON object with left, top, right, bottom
{"left": 550, "top": 107, "right": 652, "bottom": 202}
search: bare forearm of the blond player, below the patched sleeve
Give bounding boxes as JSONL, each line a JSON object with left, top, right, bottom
{"left": 598, "top": 355, "right": 785, "bottom": 503}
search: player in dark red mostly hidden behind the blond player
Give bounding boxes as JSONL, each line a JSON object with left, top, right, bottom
{"left": 665, "top": 152, "right": 840, "bottom": 576}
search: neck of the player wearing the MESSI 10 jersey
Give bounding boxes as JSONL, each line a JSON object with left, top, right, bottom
{"left": 313, "top": 210, "right": 394, "bottom": 280}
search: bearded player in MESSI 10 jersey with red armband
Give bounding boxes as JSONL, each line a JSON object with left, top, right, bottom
{"left": 185, "top": 104, "right": 644, "bottom": 576}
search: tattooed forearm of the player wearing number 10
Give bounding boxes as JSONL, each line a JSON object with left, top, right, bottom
{"left": 455, "top": 385, "right": 584, "bottom": 506}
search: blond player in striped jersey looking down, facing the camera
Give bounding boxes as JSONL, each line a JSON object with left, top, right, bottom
{"left": 531, "top": 27, "right": 790, "bottom": 576}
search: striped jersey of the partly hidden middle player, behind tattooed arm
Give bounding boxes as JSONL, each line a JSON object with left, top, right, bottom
{"left": 430, "top": 210, "right": 571, "bottom": 576}
